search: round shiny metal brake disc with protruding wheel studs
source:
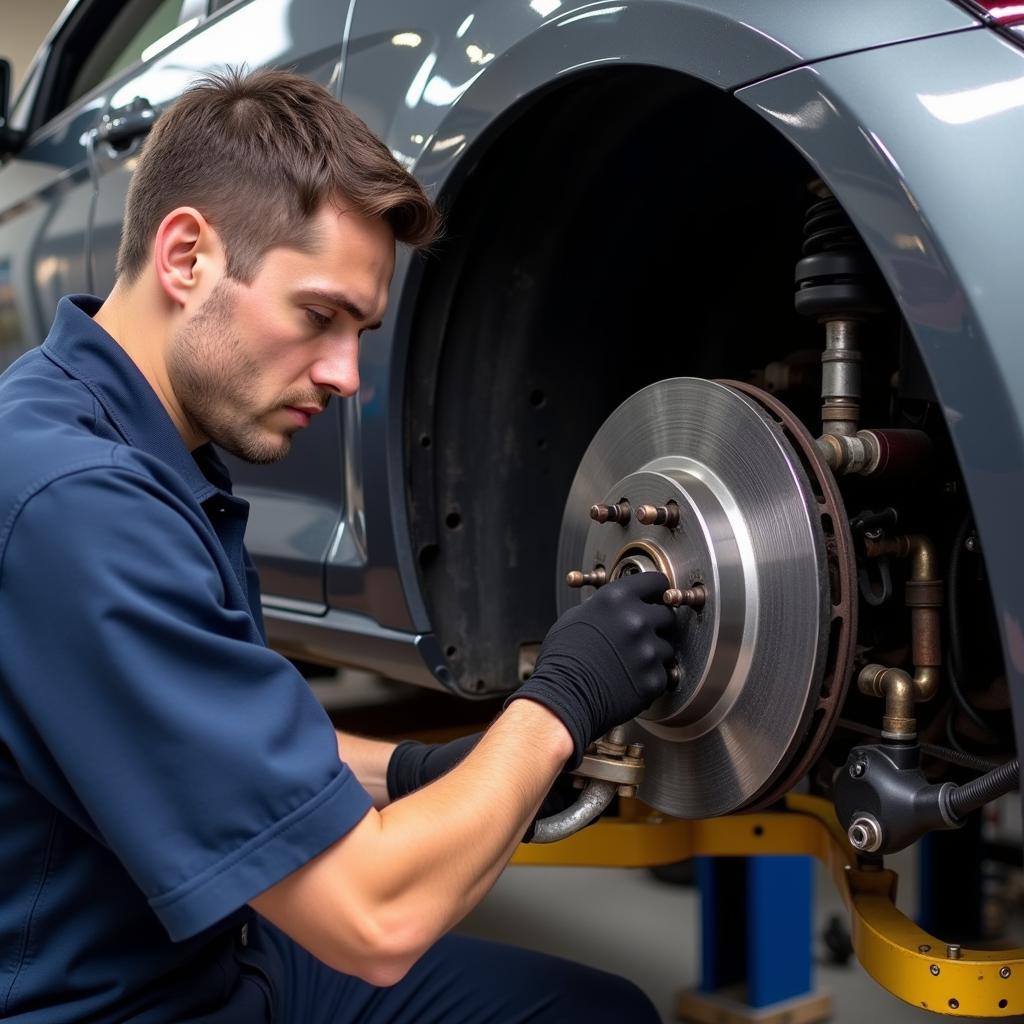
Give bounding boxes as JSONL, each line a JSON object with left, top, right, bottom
{"left": 558, "top": 378, "right": 856, "bottom": 818}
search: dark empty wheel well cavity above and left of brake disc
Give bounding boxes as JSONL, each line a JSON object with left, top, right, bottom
{"left": 404, "top": 68, "right": 819, "bottom": 694}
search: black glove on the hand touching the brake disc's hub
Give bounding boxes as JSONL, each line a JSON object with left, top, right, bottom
{"left": 505, "top": 572, "right": 676, "bottom": 768}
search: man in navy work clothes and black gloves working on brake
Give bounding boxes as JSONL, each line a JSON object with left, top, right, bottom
{"left": 0, "top": 72, "right": 673, "bottom": 1024}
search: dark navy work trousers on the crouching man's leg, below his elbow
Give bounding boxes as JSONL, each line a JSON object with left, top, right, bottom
{"left": 234, "top": 921, "right": 658, "bottom": 1024}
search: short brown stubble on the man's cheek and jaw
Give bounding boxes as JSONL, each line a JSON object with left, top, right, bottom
{"left": 167, "top": 281, "right": 297, "bottom": 465}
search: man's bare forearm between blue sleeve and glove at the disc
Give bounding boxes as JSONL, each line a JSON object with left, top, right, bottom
{"left": 260, "top": 700, "right": 572, "bottom": 985}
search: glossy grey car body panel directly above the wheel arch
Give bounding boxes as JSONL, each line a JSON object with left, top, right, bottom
{"left": 343, "top": 0, "right": 979, "bottom": 176}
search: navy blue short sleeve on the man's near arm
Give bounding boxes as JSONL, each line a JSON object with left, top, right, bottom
{"left": 0, "top": 465, "right": 372, "bottom": 940}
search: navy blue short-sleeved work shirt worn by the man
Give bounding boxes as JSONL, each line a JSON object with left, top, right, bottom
{"left": 0, "top": 296, "right": 371, "bottom": 1024}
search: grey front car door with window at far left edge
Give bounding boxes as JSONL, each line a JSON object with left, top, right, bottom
{"left": 0, "top": 0, "right": 132, "bottom": 369}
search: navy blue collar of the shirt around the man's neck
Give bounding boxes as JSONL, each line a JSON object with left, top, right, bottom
{"left": 42, "top": 295, "right": 230, "bottom": 502}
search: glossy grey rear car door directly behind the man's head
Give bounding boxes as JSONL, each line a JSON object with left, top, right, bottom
{"left": 91, "top": 0, "right": 347, "bottom": 614}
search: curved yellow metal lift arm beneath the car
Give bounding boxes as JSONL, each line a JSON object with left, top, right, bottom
{"left": 512, "top": 794, "right": 1024, "bottom": 1018}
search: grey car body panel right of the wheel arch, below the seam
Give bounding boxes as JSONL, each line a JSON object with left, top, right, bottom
{"left": 737, "top": 31, "right": 1024, "bottom": 770}
